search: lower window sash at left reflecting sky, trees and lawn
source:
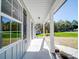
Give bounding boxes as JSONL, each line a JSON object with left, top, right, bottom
{"left": 0, "top": 16, "right": 21, "bottom": 48}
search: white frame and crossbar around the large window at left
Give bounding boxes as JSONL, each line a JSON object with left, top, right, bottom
{"left": 0, "top": 0, "right": 23, "bottom": 50}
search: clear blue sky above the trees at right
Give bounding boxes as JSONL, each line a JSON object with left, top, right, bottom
{"left": 54, "top": 0, "right": 78, "bottom": 22}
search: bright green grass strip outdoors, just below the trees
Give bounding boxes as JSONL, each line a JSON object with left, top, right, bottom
{"left": 37, "top": 32, "right": 78, "bottom": 37}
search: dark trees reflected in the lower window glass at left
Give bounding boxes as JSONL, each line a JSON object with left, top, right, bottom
{"left": 1, "top": 21, "right": 20, "bottom": 31}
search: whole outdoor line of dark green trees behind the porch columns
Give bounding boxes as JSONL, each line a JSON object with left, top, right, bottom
{"left": 35, "top": 20, "right": 78, "bottom": 33}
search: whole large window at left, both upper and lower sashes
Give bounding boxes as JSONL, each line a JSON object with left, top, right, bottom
{"left": 0, "top": 0, "right": 23, "bottom": 48}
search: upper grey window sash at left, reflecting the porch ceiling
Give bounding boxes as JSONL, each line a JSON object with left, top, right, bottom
{"left": 1, "top": 0, "right": 23, "bottom": 21}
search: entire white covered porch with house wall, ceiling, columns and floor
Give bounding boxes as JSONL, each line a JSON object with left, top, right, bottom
{"left": 0, "top": 0, "right": 66, "bottom": 59}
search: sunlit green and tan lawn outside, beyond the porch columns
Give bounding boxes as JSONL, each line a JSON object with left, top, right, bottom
{"left": 37, "top": 32, "right": 78, "bottom": 49}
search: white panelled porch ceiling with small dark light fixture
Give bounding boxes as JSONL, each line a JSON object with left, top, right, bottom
{"left": 23, "top": 0, "right": 65, "bottom": 23}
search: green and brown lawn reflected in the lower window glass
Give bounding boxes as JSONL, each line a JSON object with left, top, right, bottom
{"left": 2, "top": 31, "right": 21, "bottom": 46}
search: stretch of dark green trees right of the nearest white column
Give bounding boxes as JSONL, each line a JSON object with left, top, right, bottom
{"left": 54, "top": 20, "right": 78, "bottom": 32}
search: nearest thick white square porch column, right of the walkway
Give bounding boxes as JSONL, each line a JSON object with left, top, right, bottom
{"left": 49, "top": 15, "right": 55, "bottom": 53}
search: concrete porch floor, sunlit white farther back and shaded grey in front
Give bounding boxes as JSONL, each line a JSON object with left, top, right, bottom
{"left": 23, "top": 39, "right": 55, "bottom": 59}
